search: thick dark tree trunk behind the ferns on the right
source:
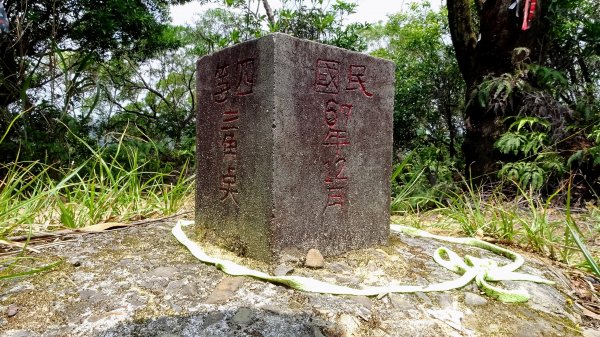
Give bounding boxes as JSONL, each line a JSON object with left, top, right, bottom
{"left": 448, "top": 0, "right": 544, "bottom": 181}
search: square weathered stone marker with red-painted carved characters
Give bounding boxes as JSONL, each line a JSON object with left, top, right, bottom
{"left": 196, "top": 34, "right": 394, "bottom": 260}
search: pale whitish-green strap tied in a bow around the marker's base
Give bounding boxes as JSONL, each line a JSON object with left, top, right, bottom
{"left": 171, "top": 220, "right": 554, "bottom": 302}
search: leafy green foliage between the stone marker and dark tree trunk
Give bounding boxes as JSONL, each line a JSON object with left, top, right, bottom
{"left": 366, "top": 3, "right": 464, "bottom": 212}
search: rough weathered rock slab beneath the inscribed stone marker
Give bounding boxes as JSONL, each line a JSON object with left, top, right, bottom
{"left": 0, "top": 220, "right": 592, "bottom": 337}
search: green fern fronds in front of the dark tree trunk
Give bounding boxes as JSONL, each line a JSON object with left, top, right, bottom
{"left": 469, "top": 37, "right": 596, "bottom": 191}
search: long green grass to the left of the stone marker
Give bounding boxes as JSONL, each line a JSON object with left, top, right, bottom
{"left": 0, "top": 133, "right": 194, "bottom": 280}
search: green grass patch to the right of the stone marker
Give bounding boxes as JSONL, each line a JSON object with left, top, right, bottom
{"left": 392, "top": 172, "right": 600, "bottom": 277}
